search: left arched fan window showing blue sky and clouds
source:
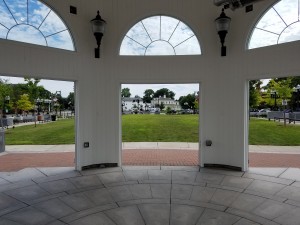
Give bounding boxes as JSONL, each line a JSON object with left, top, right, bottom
{"left": 0, "top": 0, "right": 74, "bottom": 51}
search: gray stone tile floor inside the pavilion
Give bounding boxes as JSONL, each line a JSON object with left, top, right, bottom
{"left": 0, "top": 166, "right": 300, "bottom": 225}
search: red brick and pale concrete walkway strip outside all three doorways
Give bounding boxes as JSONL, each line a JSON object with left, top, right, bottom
{"left": 0, "top": 142, "right": 300, "bottom": 171}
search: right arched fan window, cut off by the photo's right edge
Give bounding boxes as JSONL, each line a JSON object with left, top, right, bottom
{"left": 248, "top": 0, "right": 300, "bottom": 49}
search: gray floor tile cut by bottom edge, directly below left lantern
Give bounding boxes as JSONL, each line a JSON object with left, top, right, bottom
{"left": 70, "top": 212, "right": 116, "bottom": 225}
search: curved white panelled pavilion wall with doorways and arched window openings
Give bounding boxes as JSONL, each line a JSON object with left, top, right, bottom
{"left": 0, "top": 0, "right": 300, "bottom": 170}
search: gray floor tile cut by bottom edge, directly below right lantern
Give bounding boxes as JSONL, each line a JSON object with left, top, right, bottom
{"left": 197, "top": 209, "right": 240, "bottom": 225}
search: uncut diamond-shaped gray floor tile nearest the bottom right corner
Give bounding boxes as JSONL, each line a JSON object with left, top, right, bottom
{"left": 253, "top": 200, "right": 295, "bottom": 220}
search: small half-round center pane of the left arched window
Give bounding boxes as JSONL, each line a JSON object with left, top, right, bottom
{"left": 7, "top": 25, "right": 47, "bottom": 46}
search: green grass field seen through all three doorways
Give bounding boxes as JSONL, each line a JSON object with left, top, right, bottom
{"left": 5, "top": 114, "right": 300, "bottom": 146}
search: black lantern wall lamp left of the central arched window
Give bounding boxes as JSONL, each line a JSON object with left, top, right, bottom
{"left": 91, "top": 10, "right": 106, "bottom": 58}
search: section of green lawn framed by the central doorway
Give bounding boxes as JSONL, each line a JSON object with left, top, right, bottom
{"left": 122, "top": 114, "right": 199, "bottom": 142}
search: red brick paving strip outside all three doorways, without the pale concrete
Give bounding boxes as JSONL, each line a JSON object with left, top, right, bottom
{"left": 0, "top": 149, "right": 300, "bottom": 172}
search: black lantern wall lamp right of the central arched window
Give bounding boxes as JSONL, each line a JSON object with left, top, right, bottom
{"left": 215, "top": 8, "right": 231, "bottom": 56}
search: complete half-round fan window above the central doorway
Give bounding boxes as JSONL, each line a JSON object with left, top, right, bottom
{"left": 120, "top": 16, "right": 201, "bottom": 56}
